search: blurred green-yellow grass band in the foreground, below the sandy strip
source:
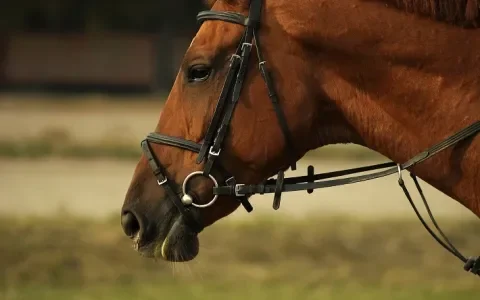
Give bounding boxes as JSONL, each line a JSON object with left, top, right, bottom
{"left": 0, "top": 214, "right": 480, "bottom": 300}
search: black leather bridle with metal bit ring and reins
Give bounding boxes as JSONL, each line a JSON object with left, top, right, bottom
{"left": 141, "top": 0, "right": 480, "bottom": 276}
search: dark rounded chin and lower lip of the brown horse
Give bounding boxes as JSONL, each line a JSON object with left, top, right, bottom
{"left": 153, "top": 216, "right": 200, "bottom": 262}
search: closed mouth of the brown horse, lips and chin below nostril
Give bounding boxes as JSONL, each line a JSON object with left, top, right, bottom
{"left": 133, "top": 216, "right": 200, "bottom": 262}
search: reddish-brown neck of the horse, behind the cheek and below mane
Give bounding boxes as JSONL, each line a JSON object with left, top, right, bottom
{"left": 284, "top": 0, "right": 480, "bottom": 217}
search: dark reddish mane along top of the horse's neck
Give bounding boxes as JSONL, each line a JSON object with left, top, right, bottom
{"left": 381, "top": 0, "right": 479, "bottom": 27}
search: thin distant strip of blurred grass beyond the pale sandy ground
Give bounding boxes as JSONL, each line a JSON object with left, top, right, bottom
{"left": 0, "top": 128, "right": 384, "bottom": 160}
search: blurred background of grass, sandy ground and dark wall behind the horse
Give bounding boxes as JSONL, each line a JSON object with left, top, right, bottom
{"left": 0, "top": 0, "right": 480, "bottom": 300}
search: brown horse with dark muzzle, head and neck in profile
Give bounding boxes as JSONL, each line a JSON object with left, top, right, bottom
{"left": 122, "top": 0, "right": 480, "bottom": 268}
